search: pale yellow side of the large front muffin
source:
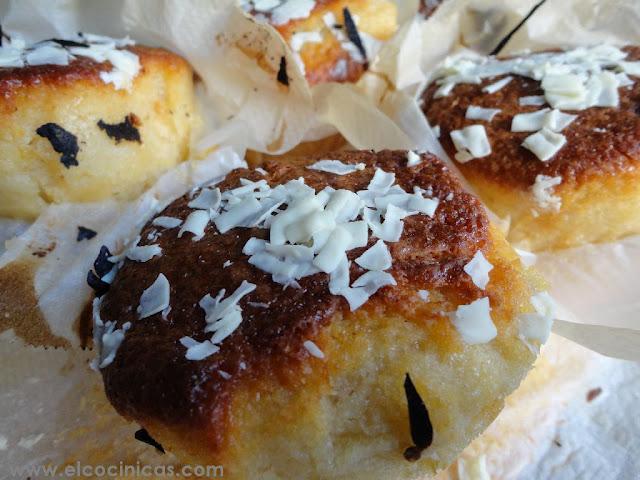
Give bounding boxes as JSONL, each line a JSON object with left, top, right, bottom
{"left": 141, "top": 229, "right": 544, "bottom": 479}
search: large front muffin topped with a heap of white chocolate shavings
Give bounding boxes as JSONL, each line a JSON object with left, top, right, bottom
{"left": 89, "top": 151, "right": 553, "bottom": 479}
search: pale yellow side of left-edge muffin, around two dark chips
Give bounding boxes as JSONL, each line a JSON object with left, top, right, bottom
{"left": 0, "top": 52, "right": 194, "bottom": 218}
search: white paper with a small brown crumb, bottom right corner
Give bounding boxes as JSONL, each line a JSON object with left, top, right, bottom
{"left": 437, "top": 335, "right": 640, "bottom": 480}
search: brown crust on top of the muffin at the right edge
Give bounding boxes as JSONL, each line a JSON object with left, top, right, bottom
{"left": 422, "top": 46, "right": 640, "bottom": 189}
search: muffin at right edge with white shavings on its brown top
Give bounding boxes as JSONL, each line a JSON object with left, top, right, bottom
{"left": 422, "top": 45, "right": 640, "bottom": 251}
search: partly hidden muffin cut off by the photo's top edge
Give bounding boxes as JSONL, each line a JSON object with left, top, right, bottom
{"left": 240, "top": 0, "right": 398, "bottom": 85}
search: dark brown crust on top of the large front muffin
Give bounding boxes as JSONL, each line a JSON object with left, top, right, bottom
{"left": 101, "top": 151, "right": 490, "bottom": 442}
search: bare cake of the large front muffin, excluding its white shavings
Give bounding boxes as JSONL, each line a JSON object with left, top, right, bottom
{"left": 101, "top": 151, "right": 537, "bottom": 478}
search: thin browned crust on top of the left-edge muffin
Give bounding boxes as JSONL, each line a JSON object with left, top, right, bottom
{"left": 0, "top": 46, "right": 191, "bottom": 99}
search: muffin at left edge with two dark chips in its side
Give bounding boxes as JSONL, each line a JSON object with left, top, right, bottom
{"left": 0, "top": 34, "right": 194, "bottom": 219}
